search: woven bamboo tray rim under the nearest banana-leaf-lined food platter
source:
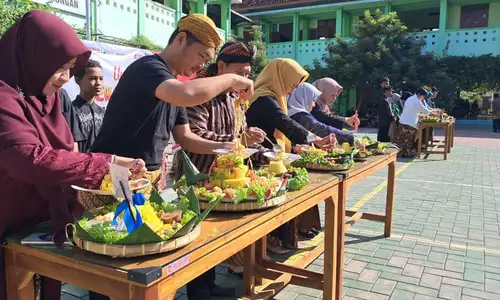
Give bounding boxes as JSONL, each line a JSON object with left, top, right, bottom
{"left": 68, "top": 224, "right": 201, "bottom": 257}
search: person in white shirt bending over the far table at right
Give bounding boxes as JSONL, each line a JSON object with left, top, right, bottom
{"left": 395, "top": 88, "right": 432, "bottom": 157}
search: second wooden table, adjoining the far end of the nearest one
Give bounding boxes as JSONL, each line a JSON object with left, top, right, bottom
{"left": 332, "top": 149, "right": 397, "bottom": 300}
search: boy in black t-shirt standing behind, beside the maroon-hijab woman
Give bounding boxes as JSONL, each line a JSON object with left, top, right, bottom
{"left": 70, "top": 60, "right": 105, "bottom": 153}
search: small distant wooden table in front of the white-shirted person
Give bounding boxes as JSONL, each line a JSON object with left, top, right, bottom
{"left": 417, "top": 122, "right": 455, "bottom": 160}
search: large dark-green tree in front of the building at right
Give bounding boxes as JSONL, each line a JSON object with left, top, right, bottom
{"left": 310, "top": 10, "right": 454, "bottom": 111}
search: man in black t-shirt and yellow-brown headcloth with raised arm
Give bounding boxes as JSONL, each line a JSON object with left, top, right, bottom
{"left": 91, "top": 14, "right": 253, "bottom": 300}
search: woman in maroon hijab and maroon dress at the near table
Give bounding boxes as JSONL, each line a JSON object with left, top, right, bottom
{"left": 0, "top": 11, "right": 145, "bottom": 300}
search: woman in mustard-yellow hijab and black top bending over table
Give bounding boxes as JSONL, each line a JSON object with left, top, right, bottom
{"left": 246, "top": 58, "right": 335, "bottom": 254}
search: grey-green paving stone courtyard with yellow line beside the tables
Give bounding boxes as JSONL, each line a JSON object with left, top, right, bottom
{"left": 63, "top": 128, "right": 500, "bottom": 300}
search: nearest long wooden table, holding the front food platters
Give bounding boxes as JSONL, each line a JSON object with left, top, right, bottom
{"left": 4, "top": 174, "right": 339, "bottom": 300}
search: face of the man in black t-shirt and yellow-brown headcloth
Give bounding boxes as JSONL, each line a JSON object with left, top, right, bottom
{"left": 175, "top": 32, "right": 215, "bottom": 77}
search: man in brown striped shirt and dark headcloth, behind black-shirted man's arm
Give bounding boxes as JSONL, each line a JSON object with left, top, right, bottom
{"left": 173, "top": 42, "right": 264, "bottom": 282}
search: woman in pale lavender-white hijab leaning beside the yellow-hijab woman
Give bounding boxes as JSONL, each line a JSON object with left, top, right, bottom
{"left": 288, "top": 82, "right": 354, "bottom": 144}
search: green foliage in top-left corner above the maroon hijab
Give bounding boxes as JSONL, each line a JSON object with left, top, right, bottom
{"left": 0, "top": 0, "right": 54, "bottom": 36}
